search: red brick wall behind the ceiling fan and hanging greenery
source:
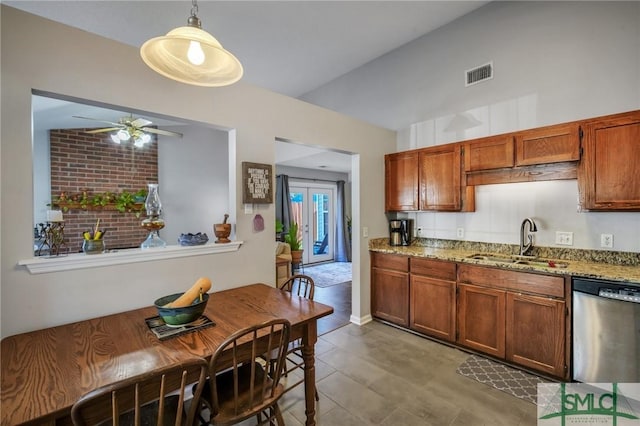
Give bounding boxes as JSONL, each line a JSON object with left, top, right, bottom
{"left": 49, "top": 129, "right": 158, "bottom": 253}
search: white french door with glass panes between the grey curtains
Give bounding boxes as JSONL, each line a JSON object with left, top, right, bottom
{"left": 289, "top": 183, "right": 336, "bottom": 264}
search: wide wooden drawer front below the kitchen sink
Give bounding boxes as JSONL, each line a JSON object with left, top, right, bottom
{"left": 458, "top": 264, "right": 564, "bottom": 298}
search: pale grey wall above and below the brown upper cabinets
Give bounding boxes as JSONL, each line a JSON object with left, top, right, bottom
{"left": 303, "top": 1, "right": 640, "bottom": 252}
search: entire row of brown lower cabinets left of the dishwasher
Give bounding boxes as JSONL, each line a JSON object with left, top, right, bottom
{"left": 371, "top": 252, "right": 570, "bottom": 379}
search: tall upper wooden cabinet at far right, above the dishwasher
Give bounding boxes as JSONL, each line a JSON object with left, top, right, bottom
{"left": 578, "top": 111, "right": 640, "bottom": 210}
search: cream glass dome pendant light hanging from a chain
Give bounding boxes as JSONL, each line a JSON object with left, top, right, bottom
{"left": 140, "top": 0, "right": 243, "bottom": 87}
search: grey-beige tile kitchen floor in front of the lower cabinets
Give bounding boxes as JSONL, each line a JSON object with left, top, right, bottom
{"left": 278, "top": 321, "right": 536, "bottom": 426}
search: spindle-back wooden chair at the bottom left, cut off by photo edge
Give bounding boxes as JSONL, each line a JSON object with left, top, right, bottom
{"left": 71, "top": 358, "right": 209, "bottom": 426}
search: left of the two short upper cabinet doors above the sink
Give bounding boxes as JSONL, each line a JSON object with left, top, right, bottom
{"left": 464, "top": 135, "right": 513, "bottom": 172}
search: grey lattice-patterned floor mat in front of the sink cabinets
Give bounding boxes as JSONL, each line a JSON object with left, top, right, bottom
{"left": 456, "top": 355, "right": 549, "bottom": 404}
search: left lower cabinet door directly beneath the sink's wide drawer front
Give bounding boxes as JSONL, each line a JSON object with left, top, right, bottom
{"left": 457, "top": 284, "right": 505, "bottom": 358}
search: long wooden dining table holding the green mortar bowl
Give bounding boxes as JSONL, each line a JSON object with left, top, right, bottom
{"left": 0, "top": 284, "right": 333, "bottom": 426}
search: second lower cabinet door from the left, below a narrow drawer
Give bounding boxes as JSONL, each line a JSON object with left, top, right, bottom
{"left": 409, "top": 275, "right": 456, "bottom": 342}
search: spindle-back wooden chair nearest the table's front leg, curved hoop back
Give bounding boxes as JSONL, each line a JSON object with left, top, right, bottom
{"left": 199, "top": 319, "right": 291, "bottom": 426}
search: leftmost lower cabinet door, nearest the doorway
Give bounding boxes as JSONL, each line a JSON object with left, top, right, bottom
{"left": 371, "top": 268, "right": 409, "bottom": 327}
